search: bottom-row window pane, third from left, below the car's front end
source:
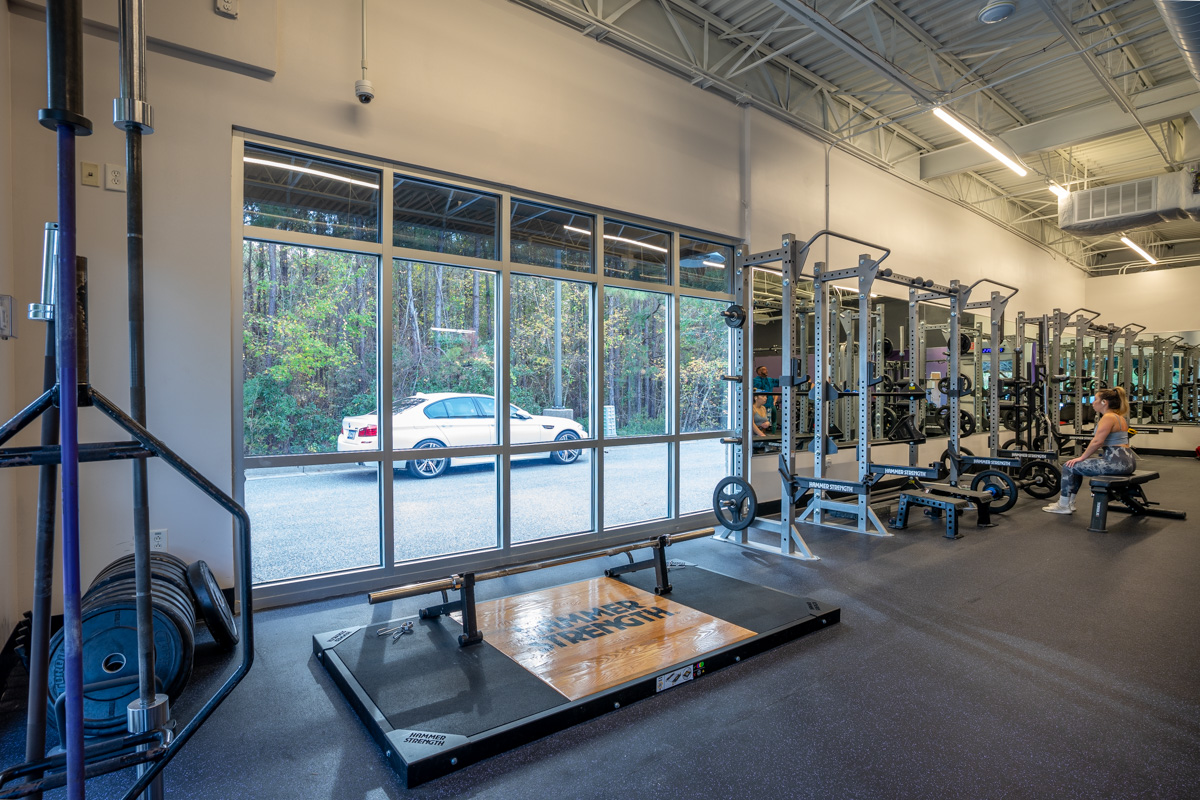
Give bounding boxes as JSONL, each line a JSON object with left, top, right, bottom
{"left": 509, "top": 449, "right": 595, "bottom": 542}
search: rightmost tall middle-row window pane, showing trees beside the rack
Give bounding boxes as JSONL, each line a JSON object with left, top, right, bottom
{"left": 679, "top": 297, "right": 731, "bottom": 431}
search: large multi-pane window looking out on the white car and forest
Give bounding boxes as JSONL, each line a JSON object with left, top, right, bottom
{"left": 235, "top": 143, "right": 733, "bottom": 599}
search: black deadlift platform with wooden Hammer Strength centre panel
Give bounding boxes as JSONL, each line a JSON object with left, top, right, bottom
{"left": 313, "top": 566, "right": 841, "bottom": 788}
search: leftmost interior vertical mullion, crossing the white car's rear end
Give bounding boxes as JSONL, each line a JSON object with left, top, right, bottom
{"left": 376, "top": 168, "right": 396, "bottom": 569}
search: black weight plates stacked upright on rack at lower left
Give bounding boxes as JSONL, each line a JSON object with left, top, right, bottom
{"left": 49, "top": 552, "right": 238, "bottom": 736}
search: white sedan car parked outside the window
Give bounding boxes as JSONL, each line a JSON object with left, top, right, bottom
{"left": 337, "top": 392, "right": 587, "bottom": 477}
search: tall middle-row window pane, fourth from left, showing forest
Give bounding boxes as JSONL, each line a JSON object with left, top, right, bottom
{"left": 604, "top": 287, "right": 668, "bottom": 437}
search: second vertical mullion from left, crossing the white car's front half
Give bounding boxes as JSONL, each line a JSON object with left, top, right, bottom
{"left": 492, "top": 193, "right": 512, "bottom": 553}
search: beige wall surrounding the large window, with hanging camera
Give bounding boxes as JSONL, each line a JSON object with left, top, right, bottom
{"left": 4, "top": 0, "right": 1081, "bottom": 606}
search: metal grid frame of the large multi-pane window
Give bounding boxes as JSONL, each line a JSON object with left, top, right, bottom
{"left": 230, "top": 130, "right": 740, "bottom": 608}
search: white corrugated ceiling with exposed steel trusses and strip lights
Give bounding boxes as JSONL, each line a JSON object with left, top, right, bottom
{"left": 512, "top": 0, "right": 1200, "bottom": 275}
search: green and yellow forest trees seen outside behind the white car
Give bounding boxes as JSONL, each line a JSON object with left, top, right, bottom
{"left": 242, "top": 240, "right": 728, "bottom": 456}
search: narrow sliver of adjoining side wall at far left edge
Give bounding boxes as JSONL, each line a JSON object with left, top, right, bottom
{"left": 0, "top": 0, "right": 17, "bottom": 646}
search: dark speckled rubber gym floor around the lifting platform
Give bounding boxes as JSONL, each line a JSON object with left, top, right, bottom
{"left": 0, "top": 457, "right": 1200, "bottom": 800}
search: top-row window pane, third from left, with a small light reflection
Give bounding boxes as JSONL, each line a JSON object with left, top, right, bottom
{"left": 509, "top": 200, "right": 595, "bottom": 272}
